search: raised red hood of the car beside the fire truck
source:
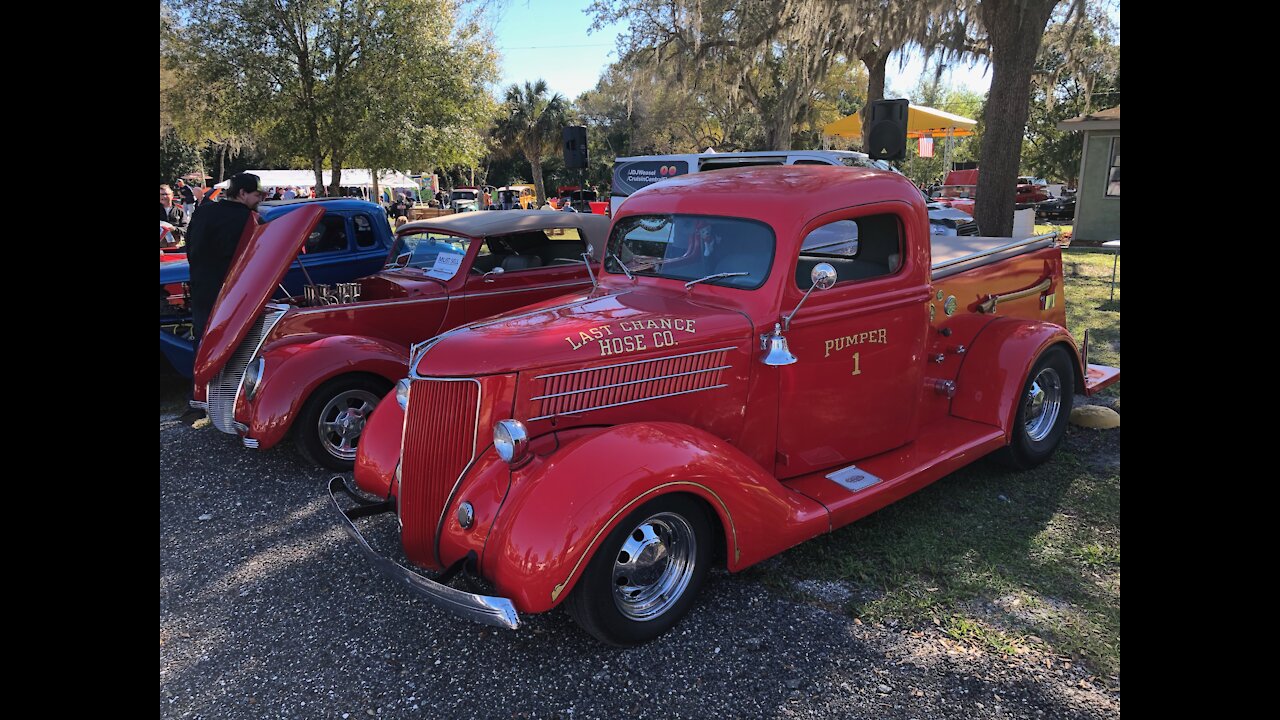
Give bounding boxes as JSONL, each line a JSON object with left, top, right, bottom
{"left": 193, "top": 205, "right": 324, "bottom": 387}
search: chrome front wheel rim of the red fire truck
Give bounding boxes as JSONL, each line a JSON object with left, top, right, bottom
{"left": 613, "top": 512, "right": 698, "bottom": 621}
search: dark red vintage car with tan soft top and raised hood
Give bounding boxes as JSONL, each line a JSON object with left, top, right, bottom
{"left": 193, "top": 204, "right": 609, "bottom": 470}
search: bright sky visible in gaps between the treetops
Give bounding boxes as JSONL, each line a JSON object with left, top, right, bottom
{"left": 489, "top": 0, "right": 991, "bottom": 109}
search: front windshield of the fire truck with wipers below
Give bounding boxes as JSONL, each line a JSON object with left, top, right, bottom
{"left": 604, "top": 215, "right": 774, "bottom": 290}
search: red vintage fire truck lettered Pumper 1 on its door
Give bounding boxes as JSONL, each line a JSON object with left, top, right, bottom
{"left": 329, "top": 167, "right": 1120, "bottom": 646}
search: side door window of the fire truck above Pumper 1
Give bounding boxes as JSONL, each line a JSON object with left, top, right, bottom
{"left": 796, "top": 214, "right": 902, "bottom": 290}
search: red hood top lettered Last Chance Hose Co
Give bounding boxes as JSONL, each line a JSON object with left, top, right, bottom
{"left": 413, "top": 286, "right": 753, "bottom": 377}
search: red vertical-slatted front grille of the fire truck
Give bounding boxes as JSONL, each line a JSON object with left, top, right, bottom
{"left": 397, "top": 379, "right": 480, "bottom": 564}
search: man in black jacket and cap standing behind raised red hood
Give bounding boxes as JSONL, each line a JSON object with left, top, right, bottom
{"left": 187, "top": 173, "right": 264, "bottom": 347}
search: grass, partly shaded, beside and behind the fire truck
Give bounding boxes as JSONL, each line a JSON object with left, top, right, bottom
{"left": 762, "top": 263, "right": 1120, "bottom": 675}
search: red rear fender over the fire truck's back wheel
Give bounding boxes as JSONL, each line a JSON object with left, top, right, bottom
{"left": 951, "top": 318, "right": 1084, "bottom": 439}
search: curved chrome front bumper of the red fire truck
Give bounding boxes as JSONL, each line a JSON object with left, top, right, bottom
{"left": 329, "top": 475, "right": 520, "bottom": 630}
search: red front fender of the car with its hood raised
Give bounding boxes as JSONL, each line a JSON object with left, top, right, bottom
{"left": 236, "top": 336, "right": 408, "bottom": 450}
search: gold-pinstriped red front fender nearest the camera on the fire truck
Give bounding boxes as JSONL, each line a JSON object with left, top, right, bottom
{"left": 481, "top": 423, "right": 831, "bottom": 612}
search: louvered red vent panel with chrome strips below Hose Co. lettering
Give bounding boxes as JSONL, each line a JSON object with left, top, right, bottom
{"left": 530, "top": 347, "right": 735, "bottom": 420}
